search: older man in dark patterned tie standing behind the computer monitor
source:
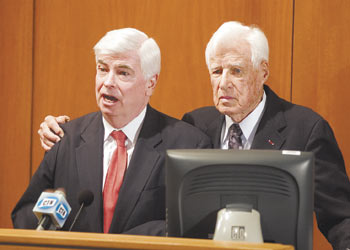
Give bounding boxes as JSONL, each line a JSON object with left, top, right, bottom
{"left": 183, "top": 22, "right": 350, "bottom": 250}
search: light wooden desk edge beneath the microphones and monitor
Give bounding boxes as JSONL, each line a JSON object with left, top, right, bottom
{"left": 0, "top": 229, "right": 294, "bottom": 250}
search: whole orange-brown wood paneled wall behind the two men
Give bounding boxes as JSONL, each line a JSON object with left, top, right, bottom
{"left": 0, "top": 0, "right": 350, "bottom": 250}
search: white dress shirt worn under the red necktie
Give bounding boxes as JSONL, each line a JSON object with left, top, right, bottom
{"left": 102, "top": 106, "right": 147, "bottom": 188}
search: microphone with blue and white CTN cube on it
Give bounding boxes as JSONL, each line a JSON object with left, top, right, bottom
{"left": 33, "top": 190, "right": 71, "bottom": 230}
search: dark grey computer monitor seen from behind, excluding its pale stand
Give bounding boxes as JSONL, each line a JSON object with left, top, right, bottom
{"left": 166, "top": 149, "right": 314, "bottom": 250}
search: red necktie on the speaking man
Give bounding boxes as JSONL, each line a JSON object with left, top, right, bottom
{"left": 103, "top": 130, "right": 127, "bottom": 233}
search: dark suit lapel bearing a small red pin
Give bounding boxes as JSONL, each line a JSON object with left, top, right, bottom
{"left": 252, "top": 86, "right": 287, "bottom": 150}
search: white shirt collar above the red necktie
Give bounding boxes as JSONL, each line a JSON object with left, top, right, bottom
{"left": 102, "top": 106, "right": 147, "bottom": 147}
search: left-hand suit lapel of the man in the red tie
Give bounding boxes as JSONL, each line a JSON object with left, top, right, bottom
{"left": 76, "top": 112, "right": 104, "bottom": 232}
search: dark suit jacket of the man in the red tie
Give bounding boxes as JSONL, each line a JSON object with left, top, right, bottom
{"left": 12, "top": 106, "right": 211, "bottom": 235}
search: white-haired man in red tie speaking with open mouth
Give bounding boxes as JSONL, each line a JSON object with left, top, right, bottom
{"left": 12, "top": 28, "right": 211, "bottom": 235}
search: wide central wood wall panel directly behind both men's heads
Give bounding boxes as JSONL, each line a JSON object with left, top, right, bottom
{"left": 32, "top": 0, "right": 293, "bottom": 170}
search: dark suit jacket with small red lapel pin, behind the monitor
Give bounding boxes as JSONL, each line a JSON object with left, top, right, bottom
{"left": 183, "top": 86, "right": 350, "bottom": 250}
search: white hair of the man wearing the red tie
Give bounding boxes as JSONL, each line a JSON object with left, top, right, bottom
{"left": 94, "top": 28, "right": 161, "bottom": 80}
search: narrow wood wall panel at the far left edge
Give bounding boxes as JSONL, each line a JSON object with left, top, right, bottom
{"left": 0, "top": 0, "right": 33, "bottom": 227}
